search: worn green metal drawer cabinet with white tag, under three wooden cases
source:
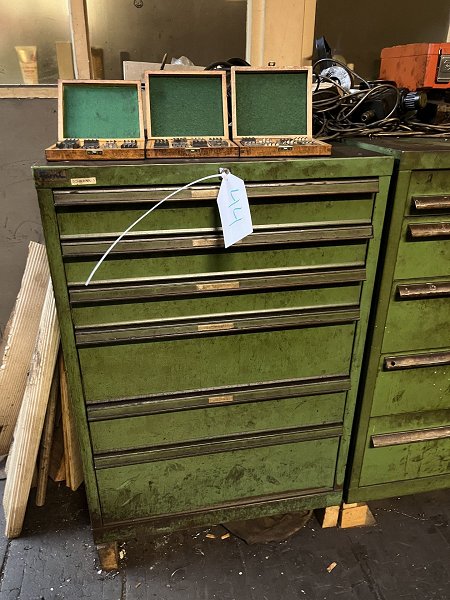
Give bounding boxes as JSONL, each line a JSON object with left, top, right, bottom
{"left": 34, "top": 148, "right": 393, "bottom": 542}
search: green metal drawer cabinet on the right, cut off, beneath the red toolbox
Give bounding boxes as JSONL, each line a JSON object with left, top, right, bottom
{"left": 347, "top": 139, "right": 450, "bottom": 502}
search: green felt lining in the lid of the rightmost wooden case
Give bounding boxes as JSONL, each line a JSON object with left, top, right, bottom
{"left": 235, "top": 71, "right": 308, "bottom": 137}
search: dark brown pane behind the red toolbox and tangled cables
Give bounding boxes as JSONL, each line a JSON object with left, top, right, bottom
{"left": 315, "top": 0, "right": 450, "bottom": 78}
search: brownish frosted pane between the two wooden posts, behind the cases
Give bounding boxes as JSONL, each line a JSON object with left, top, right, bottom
{"left": 87, "top": 0, "right": 247, "bottom": 79}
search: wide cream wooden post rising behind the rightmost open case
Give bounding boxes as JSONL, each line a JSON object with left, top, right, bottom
{"left": 246, "top": 0, "right": 316, "bottom": 67}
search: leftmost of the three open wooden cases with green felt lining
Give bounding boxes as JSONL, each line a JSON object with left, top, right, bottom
{"left": 45, "top": 80, "right": 145, "bottom": 161}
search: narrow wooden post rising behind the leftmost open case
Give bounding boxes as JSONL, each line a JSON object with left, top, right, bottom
{"left": 69, "top": 0, "right": 92, "bottom": 79}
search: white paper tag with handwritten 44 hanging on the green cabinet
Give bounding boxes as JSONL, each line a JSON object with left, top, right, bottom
{"left": 217, "top": 173, "right": 253, "bottom": 248}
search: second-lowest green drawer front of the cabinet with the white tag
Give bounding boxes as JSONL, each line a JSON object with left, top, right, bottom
{"left": 89, "top": 392, "right": 346, "bottom": 456}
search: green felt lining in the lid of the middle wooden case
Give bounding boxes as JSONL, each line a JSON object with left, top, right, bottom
{"left": 148, "top": 74, "right": 224, "bottom": 137}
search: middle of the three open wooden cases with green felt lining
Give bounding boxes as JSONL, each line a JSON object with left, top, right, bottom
{"left": 144, "top": 71, "right": 239, "bottom": 158}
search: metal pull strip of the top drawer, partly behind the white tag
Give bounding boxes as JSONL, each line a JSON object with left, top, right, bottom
{"left": 54, "top": 177, "right": 379, "bottom": 206}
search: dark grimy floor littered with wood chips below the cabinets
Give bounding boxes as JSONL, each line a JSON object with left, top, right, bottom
{"left": 0, "top": 482, "right": 450, "bottom": 600}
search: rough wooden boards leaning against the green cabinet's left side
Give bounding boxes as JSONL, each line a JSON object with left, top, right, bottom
{"left": 0, "top": 242, "right": 83, "bottom": 538}
